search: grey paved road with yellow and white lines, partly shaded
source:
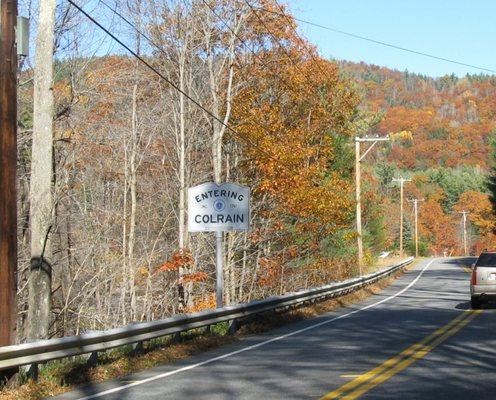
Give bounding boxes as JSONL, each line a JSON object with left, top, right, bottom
{"left": 52, "top": 259, "right": 496, "bottom": 400}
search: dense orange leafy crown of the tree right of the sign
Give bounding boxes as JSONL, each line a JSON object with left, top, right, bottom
{"left": 233, "top": 49, "right": 358, "bottom": 242}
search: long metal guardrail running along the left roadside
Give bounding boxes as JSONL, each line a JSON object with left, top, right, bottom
{"left": 0, "top": 257, "right": 413, "bottom": 371}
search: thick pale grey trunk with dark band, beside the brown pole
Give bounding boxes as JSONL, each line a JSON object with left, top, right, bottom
{"left": 27, "top": 0, "right": 56, "bottom": 339}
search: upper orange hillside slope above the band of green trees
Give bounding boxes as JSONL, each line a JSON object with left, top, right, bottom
{"left": 342, "top": 62, "right": 496, "bottom": 169}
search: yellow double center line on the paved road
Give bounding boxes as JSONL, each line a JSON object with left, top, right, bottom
{"left": 320, "top": 310, "right": 481, "bottom": 400}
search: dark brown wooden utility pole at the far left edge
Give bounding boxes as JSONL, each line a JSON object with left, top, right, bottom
{"left": 0, "top": 0, "right": 17, "bottom": 346}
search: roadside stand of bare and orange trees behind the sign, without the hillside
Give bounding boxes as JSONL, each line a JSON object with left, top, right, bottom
{"left": 14, "top": 0, "right": 360, "bottom": 337}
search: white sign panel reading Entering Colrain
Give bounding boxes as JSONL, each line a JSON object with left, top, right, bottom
{"left": 188, "top": 182, "right": 250, "bottom": 232}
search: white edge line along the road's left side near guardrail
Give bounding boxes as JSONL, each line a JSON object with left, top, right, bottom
{"left": 73, "top": 259, "right": 436, "bottom": 400}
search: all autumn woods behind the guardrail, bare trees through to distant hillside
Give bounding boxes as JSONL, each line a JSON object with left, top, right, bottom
{"left": 14, "top": 0, "right": 493, "bottom": 344}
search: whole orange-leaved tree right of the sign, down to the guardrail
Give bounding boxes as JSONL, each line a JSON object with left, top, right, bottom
{"left": 233, "top": 41, "right": 358, "bottom": 285}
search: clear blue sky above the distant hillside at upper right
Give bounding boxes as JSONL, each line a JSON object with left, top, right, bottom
{"left": 286, "top": 0, "right": 496, "bottom": 76}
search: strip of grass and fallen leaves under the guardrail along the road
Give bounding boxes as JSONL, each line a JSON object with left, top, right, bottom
{"left": 0, "top": 259, "right": 422, "bottom": 400}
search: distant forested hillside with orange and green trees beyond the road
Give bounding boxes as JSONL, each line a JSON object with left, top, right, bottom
{"left": 339, "top": 62, "right": 496, "bottom": 254}
